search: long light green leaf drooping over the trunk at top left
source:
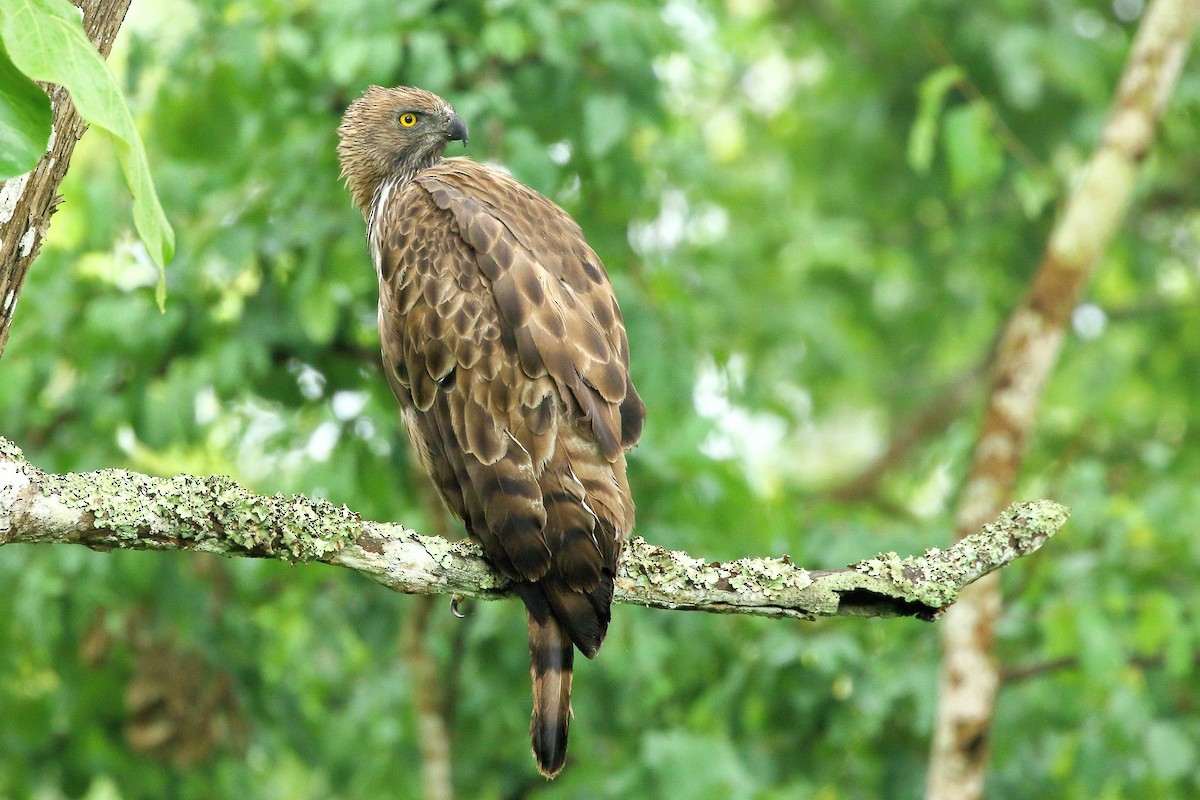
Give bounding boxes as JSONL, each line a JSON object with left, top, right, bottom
{"left": 0, "top": 0, "right": 175, "bottom": 275}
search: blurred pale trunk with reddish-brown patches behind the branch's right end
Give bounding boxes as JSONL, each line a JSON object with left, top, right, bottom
{"left": 925, "top": 0, "right": 1200, "bottom": 800}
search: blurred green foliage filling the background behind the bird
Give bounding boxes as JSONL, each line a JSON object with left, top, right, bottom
{"left": 0, "top": 0, "right": 1200, "bottom": 800}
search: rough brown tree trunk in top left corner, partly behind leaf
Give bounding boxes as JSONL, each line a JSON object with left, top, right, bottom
{"left": 0, "top": 0, "right": 130, "bottom": 356}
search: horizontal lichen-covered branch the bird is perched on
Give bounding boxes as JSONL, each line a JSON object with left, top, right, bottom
{"left": 0, "top": 438, "right": 1068, "bottom": 619}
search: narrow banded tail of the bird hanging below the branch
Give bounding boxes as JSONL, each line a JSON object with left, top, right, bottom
{"left": 528, "top": 613, "right": 575, "bottom": 777}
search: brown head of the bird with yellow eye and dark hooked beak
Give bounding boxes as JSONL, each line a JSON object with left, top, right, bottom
{"left": 337, "top": 86, "right": 467, "bottom": 213}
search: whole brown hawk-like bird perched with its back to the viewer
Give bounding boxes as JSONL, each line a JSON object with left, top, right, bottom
{"left": 337, "top": 86, "right": 646, "bottom": 777}
